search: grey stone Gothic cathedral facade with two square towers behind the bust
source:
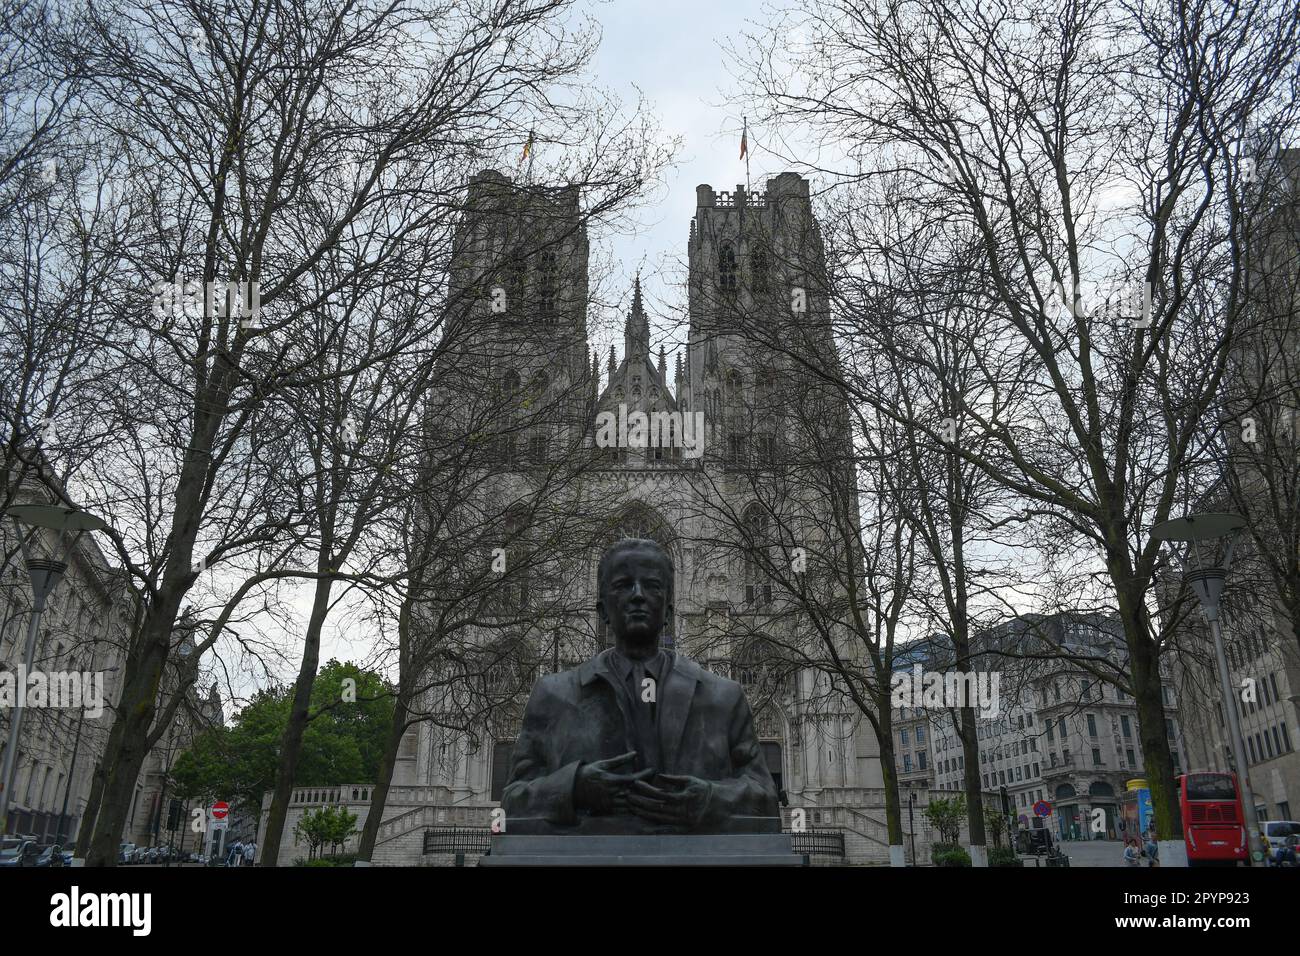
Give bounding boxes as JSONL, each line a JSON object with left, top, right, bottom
{"left": 374, "top": 172, "right": 888, "bottom": 864}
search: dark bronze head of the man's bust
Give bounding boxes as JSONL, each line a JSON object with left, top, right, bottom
{"left": 595, "top": 537, "right": 673, "bottom": 648}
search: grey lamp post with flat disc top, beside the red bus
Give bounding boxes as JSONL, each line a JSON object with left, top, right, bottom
{"left": 1151, "top": 514, "right": 1262, "bottom": 865}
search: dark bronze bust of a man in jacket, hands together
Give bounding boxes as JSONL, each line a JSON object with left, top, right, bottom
{"left": 502, "top": 538, "right": 780, "bottom": 832}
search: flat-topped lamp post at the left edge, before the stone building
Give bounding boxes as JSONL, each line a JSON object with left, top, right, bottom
{"left": 0, "top": 505, "right": 108, "bottom": 834}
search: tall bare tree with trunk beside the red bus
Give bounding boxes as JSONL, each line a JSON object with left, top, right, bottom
{"left": 748, "top": 0, "right": 1297, "bottom": 858}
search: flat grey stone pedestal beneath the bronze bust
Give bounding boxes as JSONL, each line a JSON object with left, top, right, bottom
{"left": 478, "top": 832, "right": 807, "bottom": 866}
